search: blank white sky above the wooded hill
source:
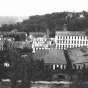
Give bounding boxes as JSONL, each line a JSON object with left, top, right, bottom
{"left": 0, "top": 0, "right": 88, "bottom": 16}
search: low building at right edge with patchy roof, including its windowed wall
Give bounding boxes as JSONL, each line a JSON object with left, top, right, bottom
{"left": 67, "top": 47, "right": 88, "bottom": 70}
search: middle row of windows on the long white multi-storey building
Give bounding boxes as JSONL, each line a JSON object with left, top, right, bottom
{"left": 57, "top": 40, "right": 88, "bottom": 44}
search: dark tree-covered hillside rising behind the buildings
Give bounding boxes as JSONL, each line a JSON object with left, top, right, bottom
{"left": 0, "top": 11, "right": 88, "bottom": 34}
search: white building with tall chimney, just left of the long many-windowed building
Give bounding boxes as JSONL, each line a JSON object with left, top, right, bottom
{"left": 31, "top": 29, "right": 55, "bottom": 53}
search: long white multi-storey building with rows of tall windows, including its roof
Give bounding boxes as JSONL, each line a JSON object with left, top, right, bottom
{"left": 55, "top": 31, "right": 88, "bottom": 49}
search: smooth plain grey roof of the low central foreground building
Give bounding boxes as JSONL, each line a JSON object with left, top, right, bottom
{"left": 33, "top": 49, "right": 66, "bottom": 64}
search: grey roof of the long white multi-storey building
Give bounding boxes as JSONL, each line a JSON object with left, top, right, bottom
{"left": 56, "top": 31, "right": 86, "bottom": 36}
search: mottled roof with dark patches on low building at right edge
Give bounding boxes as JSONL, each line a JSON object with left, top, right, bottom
{"left": 68, "top": 47, "right": 88, "bottom": 64}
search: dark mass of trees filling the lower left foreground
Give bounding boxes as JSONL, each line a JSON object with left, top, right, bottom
{"left": 0, "top": 41, "right": 44, "bottom": 88}
